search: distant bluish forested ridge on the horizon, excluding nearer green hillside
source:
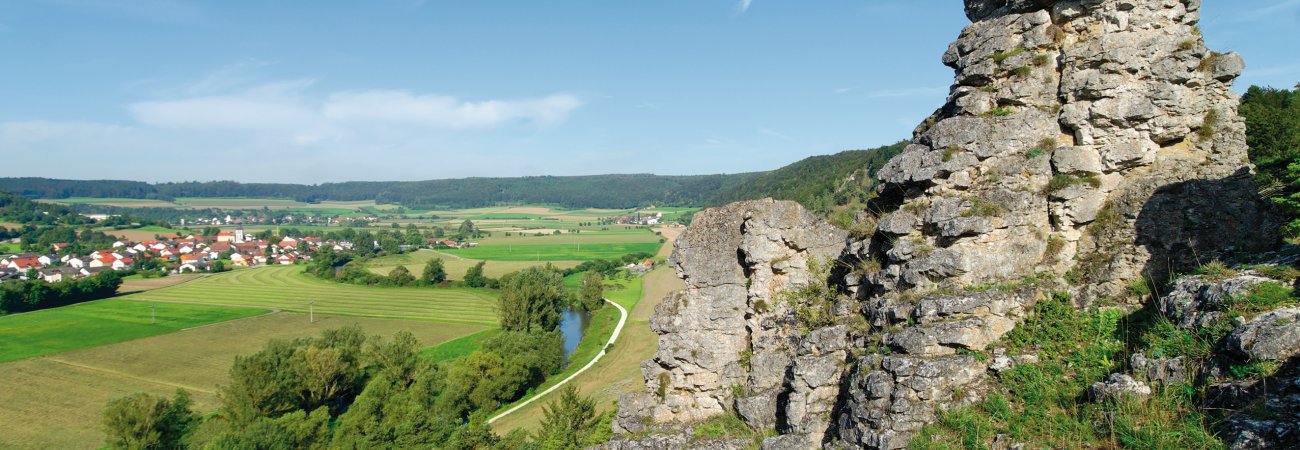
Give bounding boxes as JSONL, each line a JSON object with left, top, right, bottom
{"left": 0, "top": 173, "right": 755, "bottom": 208}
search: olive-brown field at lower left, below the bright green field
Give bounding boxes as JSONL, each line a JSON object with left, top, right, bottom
{"left": 0, "top": 310, "right": 486, "bottom": 449}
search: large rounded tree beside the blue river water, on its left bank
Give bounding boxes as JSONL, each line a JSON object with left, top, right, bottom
{"left": 496, "top": 264, "right": 564, "bottom": 333}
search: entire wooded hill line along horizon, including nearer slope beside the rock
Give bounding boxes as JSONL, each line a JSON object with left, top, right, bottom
{"left": 0, "top": 142, "right": 906, "bottom": 213}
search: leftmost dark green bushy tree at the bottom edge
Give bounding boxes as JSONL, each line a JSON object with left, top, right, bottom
{"left": 104, "top": 389, "right": 198, "bottom": 449}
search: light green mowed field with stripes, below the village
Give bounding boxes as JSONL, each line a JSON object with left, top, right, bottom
{"left": 125, "top": 265, "right": 497, "bottom": 326}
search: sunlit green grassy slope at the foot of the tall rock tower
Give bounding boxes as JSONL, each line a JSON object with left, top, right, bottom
{"left": 910, "top": 291, "right": 1223, "bottom": 450}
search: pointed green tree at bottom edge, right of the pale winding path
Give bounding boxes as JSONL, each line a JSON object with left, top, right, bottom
{"left": 534, "top": 385, "right": 602, "bottom": 450}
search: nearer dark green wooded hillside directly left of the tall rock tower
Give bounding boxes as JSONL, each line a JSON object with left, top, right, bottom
{"left": 709, "top": 140, "right": 907, "bottom": 212}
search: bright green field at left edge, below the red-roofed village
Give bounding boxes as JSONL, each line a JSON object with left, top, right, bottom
{"left": 0, "top": 299, "right": 269, "bottom": 362}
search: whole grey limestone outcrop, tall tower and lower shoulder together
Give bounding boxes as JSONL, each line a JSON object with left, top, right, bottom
{"left": 615, "top": 0, "right": 1286, "bottom": 449}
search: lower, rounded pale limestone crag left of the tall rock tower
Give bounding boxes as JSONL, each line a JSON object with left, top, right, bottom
{"left": 615, "top": 200, "right": 849, "bottom": 441}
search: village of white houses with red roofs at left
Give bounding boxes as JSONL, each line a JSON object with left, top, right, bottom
{"left": 0, "top": 229, "right": 352, "bottom": 282}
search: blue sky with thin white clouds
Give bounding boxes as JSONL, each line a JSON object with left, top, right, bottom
{"left": 0, "top": 0, "right": 1300, "bottom": 183}
